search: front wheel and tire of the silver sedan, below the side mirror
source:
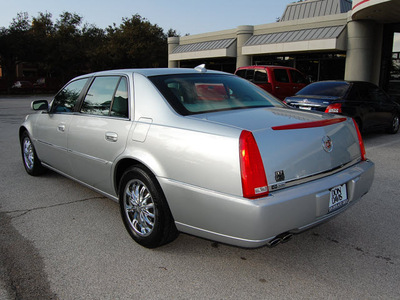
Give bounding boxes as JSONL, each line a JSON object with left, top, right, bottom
{"left": 21, "top": 131, "right": 46, "bottom": 176}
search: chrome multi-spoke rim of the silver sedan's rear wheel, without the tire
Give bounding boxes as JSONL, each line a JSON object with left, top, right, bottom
{"left": 123, "top": 179, "right": 156, "bottom": 237}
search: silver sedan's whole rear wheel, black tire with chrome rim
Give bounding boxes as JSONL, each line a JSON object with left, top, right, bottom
{"left": 119, "top": 167, "right": 178, "bottom": 248}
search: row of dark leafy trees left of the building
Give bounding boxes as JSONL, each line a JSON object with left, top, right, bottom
{"left": 0, "top": 12, "right": 179, "bottom": 91}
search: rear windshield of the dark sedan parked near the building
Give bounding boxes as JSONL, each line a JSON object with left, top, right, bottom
{"left": 296, "top": 82, "right": 350, "bottom": 97}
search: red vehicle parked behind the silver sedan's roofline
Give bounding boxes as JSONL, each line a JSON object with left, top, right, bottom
{"left": 235, "top": 66, "right": 310, "bottom": 100}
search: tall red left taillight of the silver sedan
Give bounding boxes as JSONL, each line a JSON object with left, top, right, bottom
{"left": 239, "top": 130, "right": 269, "bottom": 199}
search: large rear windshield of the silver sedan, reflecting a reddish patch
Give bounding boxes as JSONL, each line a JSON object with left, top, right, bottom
{"left": 149, "top": 74, "right": 284, "bottom": 115}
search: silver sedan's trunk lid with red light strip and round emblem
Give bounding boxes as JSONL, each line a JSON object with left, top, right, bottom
{"left": 192, "top": 108, "right": 361, "bottom": 190}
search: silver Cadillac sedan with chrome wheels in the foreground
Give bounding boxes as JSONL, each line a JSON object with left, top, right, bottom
{"left": 19, "top": 66, "right": 374, "bottom": 248}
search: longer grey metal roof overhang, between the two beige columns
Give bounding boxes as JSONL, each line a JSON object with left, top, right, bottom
{"left": 242, "top": 25, "right": 347, "bottom": 55}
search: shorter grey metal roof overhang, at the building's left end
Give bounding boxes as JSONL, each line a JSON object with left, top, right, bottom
{"left": 169, "top": 38, "right": 237, "bottom": 61}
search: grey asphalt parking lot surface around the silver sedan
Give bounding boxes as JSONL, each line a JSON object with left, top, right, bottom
{"left": 0, "top": 96, "right": 400, "bottom": 299}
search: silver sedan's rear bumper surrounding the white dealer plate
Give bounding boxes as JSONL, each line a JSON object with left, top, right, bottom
{"left": 158, "top": 160, "right": 375, "bottom": 248}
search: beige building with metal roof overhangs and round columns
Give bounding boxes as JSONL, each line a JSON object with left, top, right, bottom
{"left": 168, "top": 0, "right": 400, "bottom": 87}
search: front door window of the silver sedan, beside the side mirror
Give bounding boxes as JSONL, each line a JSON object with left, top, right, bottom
{"left": 51, "top": 78, "right": 89, "bottom": 113}
